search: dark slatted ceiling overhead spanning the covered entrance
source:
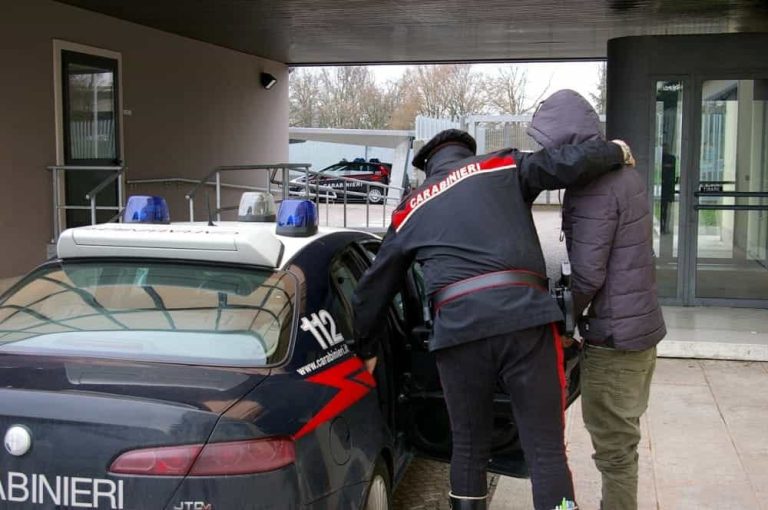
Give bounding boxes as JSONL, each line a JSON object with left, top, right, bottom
{"left": 54, "top": 0, "right": 768, "bottom": 65}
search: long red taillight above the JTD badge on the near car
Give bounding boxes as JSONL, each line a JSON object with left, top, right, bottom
{"left": 109, "top": 438, "right": 296, "bottom": 476}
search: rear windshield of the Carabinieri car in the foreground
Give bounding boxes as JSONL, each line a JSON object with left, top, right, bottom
{"left": 0, "top": 261, "right": 296, "bottom": 367}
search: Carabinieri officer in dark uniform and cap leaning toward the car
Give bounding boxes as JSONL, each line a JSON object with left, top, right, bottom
{"left": 354, "top": 129, "right": 631, "bottom": 510}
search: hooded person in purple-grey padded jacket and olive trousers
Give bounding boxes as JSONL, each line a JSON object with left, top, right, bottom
{"left": 528, "top": 90, "right": 666, "bottom": 510}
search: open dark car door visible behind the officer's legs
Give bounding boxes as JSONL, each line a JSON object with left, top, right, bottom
{"left": 401, "top": 263, "right": 579, "bottom": 477}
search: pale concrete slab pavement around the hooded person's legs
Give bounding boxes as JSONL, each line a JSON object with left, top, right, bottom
{"left": 491, "top": 359, "right": 768, "bottom": 510}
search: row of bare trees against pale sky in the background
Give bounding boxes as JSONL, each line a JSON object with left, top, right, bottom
{"left": 290, "top": 64, "right": 568, "bottom": 129}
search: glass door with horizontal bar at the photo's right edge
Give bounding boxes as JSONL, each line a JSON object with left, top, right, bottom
{"left": 691, "top": 78, "right": 768, "bottom": 307}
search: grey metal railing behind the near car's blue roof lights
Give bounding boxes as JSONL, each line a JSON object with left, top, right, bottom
{"left": 185, "top": 163, "right": 403, "bottom": 228}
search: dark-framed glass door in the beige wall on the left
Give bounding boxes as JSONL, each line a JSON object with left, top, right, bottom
{"left": 61, "top": 50, "right": 121, "bottom": 227}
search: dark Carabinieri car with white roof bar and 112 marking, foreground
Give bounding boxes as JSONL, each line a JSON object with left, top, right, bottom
{"left": 0, "top": 194, "right": 577, "bottom": 510}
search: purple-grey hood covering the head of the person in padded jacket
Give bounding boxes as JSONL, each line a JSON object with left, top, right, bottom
{"left": 527, "top": 89, "right": 603, "bottom": 149}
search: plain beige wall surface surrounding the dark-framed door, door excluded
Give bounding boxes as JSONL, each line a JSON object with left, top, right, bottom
{"left": 0, "top": 0, "right": 288, "bottom": 278}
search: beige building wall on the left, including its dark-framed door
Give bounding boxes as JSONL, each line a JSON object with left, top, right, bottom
{"left": 0, "top": 0, "right": 288, "bottom": 279}
